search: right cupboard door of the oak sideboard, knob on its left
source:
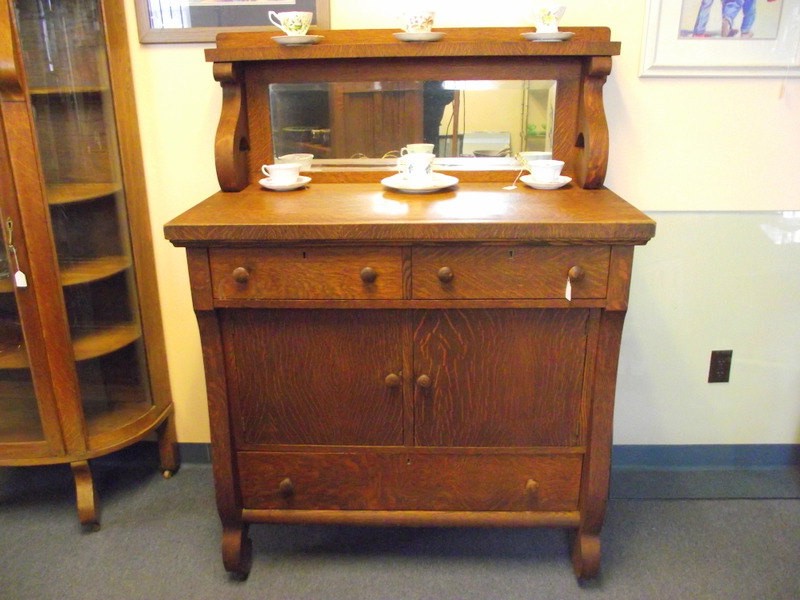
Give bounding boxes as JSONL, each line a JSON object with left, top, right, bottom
{"left": 414, "top": 309, "right": 589, "bottom": 447}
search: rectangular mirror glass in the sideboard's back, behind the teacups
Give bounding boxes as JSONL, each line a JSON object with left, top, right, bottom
{"left": 269, "top": 80, "right": 556, "bottom": 169}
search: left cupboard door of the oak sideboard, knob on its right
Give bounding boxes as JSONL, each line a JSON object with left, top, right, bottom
{"left": 220, "top": 309, "right": 403, "bottom": 448}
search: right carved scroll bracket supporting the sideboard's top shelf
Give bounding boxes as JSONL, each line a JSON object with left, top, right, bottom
{"left": 576, "top": 56, "right": 611, "bottom": 189}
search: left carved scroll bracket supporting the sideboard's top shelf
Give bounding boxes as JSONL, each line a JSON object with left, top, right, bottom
{"left": 214, "top": 62, "right": 250, "bottom": 192}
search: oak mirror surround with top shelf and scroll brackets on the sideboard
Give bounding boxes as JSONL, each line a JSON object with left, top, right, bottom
{"left": 206, "top": 27, "right": 620, "bottom": 191}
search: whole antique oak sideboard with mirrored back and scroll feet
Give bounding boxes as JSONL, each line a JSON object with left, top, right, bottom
{"left": 165, "top": 28, "right": 655, "bottom": 577}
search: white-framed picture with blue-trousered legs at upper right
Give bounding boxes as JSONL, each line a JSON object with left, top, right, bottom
{"left": 640, "top": 0, "right": 800, "bottom": 77}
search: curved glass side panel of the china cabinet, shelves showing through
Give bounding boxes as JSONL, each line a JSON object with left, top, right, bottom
{"left": 15, "top": 0, "right": 152, "bottom": 448}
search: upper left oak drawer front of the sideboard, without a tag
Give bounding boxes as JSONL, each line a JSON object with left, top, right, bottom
{"left": 210, "top": 247, "right": 403, "bottom": 300}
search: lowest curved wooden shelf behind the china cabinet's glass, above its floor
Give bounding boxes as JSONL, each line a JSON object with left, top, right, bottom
{"left": 0, "top": 323, "right": 141, "bottom": 369}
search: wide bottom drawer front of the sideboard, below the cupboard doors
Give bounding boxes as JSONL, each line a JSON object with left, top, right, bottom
{"left": 238, "top": 451, "right": 582, "bottom": 511}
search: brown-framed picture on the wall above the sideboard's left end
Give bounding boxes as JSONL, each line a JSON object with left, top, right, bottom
{"left": 135, "top": 0, "right": 330, "bottom": 44}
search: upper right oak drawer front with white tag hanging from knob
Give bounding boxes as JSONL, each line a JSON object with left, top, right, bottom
{"left": 411, "top": 246, "right": 611, "bottom": 299}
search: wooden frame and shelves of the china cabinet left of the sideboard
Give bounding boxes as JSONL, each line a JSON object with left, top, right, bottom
{"left": 0, "top": 0, "right": 179, "bottom": 527}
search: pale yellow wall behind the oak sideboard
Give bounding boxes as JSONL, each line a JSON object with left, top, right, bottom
{"left": 126, "top": 0, "right": 800, "bottom": 444}
